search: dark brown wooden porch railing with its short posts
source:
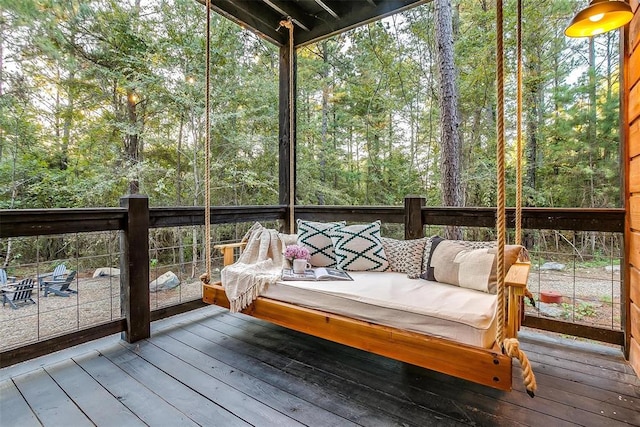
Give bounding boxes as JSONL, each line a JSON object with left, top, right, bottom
{"left": 0, "top": 195, "right": 625, "bottom": 367}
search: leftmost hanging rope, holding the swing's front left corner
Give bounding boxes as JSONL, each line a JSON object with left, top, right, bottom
{"left": 200, "top": 0, "right": 211, "bottom": 284}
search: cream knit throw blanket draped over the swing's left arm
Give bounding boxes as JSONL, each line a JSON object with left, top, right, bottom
{"left": 220, "top": 223, "right": 285, "bottom": 313}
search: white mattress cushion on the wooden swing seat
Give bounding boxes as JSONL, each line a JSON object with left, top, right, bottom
{"left": 262, "top": 272, "right": 497, "bottom": 348}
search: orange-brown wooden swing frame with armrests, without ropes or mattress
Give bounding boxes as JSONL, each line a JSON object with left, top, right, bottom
{"left": 203, "top": 247, "right": 530, "bottom": 391}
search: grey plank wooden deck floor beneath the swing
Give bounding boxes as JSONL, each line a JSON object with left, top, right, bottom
{"left": 0, "top": 307, "right": 640, "bottom": 427}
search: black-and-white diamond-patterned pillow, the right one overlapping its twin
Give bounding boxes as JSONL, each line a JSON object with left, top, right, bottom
{"left": 331, "top": 221, "right": 389, "bottom": 271}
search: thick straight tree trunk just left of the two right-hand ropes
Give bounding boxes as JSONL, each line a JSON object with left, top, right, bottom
{"left": 436, "top": 0, "right": 462, "bottom": 239}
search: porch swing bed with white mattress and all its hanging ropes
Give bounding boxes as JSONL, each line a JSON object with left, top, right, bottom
{"left": 201, "top": 0, "right": 536, "bottom": 397}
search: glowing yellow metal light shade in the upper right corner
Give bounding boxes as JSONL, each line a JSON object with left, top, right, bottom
{"left": 564, "top": 0, "right": 633, "bottom": 37}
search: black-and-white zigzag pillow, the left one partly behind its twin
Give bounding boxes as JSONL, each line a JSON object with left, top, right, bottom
{"left": 297, "top": 219, "right": 345, "bottom": 267}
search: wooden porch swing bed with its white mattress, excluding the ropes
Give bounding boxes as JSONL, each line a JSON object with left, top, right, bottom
{"left": 203, "top": 234, "right": 530, "bottom": 390}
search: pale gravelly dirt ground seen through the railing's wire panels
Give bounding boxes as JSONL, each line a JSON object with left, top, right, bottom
{"left": 0, "top": 268, "right": 620, "bottom": 351}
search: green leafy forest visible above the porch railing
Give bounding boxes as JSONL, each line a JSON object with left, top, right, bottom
{"left": 0, "top": 0, "right": 621, "bottom": 209}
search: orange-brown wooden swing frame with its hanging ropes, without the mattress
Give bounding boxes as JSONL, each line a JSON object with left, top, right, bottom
{"left": 202, "top": 0, "right": 535, "bottom": 396}
